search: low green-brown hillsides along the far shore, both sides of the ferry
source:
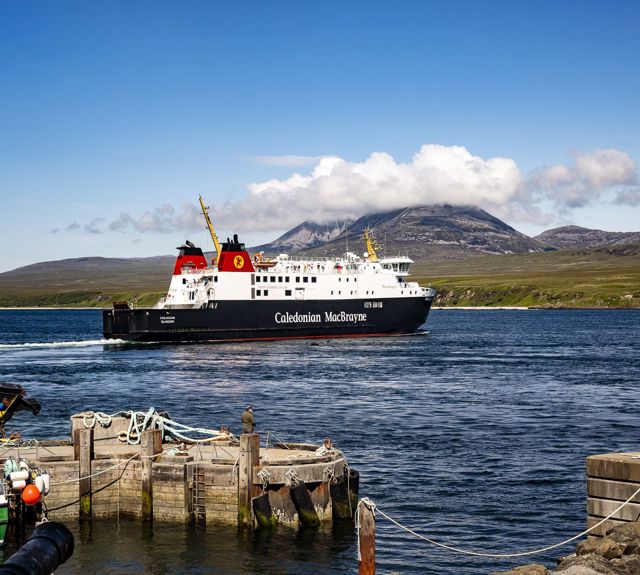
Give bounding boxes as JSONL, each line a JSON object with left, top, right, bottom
{"left": 0, "top": 248, "right": 640, "bottom": 307}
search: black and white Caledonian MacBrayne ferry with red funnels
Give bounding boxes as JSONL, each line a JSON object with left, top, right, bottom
{"left": 103, "top": 197, "right": 436, "bottom": 342}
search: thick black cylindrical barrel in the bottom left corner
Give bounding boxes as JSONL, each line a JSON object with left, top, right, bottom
{"left": 0, "top": 521, "right": 73, "bottom": 575}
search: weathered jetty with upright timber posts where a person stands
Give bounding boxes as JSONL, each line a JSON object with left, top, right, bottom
{"left": 0, "top": 415, "right": 357, "bottom": 526}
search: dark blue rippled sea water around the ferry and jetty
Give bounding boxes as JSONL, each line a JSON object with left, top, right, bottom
{"left": 0, "top": 310, "right": 640, "bottom": 575}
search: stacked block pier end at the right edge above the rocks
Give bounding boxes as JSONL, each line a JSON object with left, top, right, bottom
{"left": 587, "top": 452, "right": 640, "bottom": 536}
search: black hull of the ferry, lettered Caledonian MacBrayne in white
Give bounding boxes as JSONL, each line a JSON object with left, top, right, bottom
{"left": 102, "top": 297, "right": 432, "bottom": 342}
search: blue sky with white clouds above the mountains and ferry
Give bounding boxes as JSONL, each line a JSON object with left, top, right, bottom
{"left": 0, "top": 0, "right": 640, "bottom": 271}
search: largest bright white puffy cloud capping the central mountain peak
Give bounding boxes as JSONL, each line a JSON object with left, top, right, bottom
{"left": 216, "top": 144, "right": 522, "bottom": 231}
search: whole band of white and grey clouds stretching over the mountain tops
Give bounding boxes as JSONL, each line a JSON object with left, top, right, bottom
{"left": 58, "top": 144, "right": 640, "bottom": 233}
